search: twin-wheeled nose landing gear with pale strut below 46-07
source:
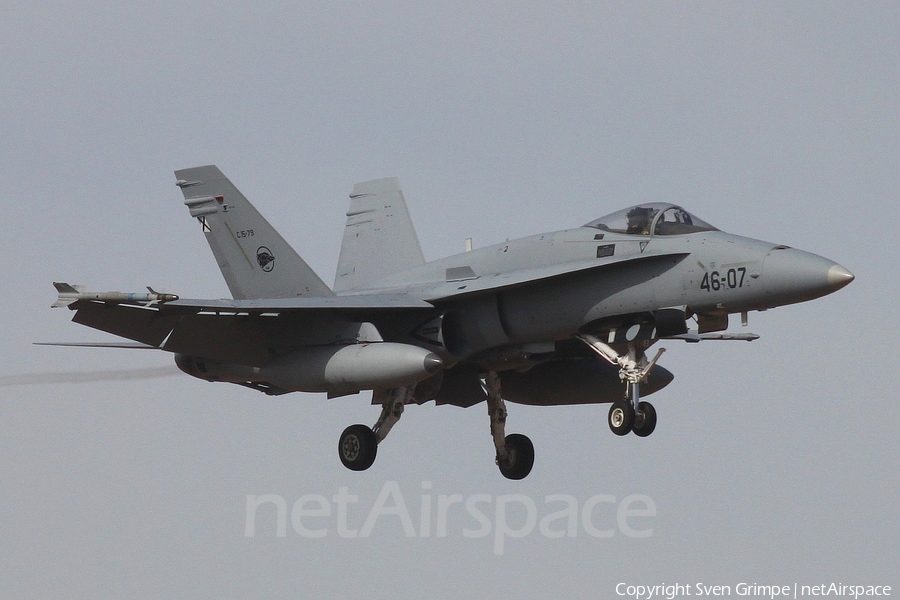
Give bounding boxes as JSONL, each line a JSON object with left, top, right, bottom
{"left": 581, "top": 335, "right": 666, "bottom": 437}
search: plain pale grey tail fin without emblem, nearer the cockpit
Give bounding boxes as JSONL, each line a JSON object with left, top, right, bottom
{"left": 334, "top": 177, "right": 425, "bottom": 291}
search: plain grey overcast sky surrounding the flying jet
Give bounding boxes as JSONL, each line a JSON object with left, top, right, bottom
{"left": 0, "top": 0, "right": 900, "bottom": 598}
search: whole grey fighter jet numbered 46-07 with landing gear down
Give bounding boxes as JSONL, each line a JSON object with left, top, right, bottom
{"left": 45, "top": 166, "right": 853, "bottom": 479}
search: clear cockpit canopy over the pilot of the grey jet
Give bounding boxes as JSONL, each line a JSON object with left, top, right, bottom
{"left": 585, "top": 202, "right": 718, "bottom": 235}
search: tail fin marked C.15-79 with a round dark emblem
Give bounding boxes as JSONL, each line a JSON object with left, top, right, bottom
{"left": 175, "top": 165, "right": 334, "bottom": 300}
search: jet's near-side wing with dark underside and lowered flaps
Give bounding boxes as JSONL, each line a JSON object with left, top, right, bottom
{"left": 63, "top": 295, "right": 435, "bottom": 366}
